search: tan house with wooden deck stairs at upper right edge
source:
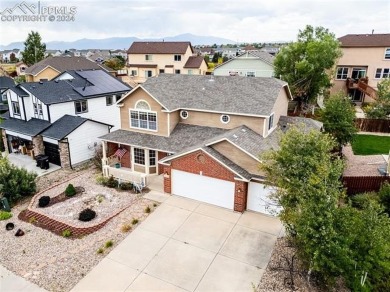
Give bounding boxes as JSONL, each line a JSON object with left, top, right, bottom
{"left": 331, "top": 34, "right": 390, "bottom": 102}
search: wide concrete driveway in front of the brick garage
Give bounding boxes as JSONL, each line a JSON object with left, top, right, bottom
{"left": 72, "top": 196, "right": 282, "bottom": 292}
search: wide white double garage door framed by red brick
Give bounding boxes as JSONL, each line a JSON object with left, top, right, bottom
{"left": 171, "top": 170, "right": 234, "bottom": 209}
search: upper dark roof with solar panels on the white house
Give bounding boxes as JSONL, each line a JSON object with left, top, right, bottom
{"left": 21, "top": 70, "right": 131, "bottom": 104}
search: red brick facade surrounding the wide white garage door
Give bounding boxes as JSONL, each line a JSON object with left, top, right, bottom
{"left": 163, "top": 150, "right": 248, "bottom": 212}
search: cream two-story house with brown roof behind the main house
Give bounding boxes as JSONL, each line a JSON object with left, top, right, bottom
{"left": 127, "top": 42, "right": 207, "bottom": 83}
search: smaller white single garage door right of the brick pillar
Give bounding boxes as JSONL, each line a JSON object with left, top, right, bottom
{"left": 246, "top": 182, "right": 281, "bottom": 216}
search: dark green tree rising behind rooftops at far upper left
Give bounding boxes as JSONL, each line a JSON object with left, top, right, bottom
{"left": 22, "top": 31, "right": 46, "bottom": 66}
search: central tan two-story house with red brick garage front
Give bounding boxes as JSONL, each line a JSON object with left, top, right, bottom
{"left": 100, "top": 74, "right": 320, "bottom": 212}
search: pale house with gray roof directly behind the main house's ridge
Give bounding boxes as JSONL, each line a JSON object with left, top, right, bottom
{"left": 214, "top": 51, "right": 274, "bottom": 77}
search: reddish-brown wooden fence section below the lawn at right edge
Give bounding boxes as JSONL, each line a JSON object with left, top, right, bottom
{"left": 342, "top": 176, "right": 390, "bottom": 195}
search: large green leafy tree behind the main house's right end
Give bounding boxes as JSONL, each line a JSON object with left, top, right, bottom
{"left": 274, "top": 25, "right": 342, "bottom": 101}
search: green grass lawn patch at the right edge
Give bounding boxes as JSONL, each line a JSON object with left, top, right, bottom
{"left": 352, "top": 135, "right": 390, "bottom": 155}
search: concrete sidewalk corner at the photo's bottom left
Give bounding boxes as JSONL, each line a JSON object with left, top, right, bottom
{"left": 0, "top": 265, "right": 46, "bottom": 292}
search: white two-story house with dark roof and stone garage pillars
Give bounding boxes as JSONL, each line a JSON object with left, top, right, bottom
{"left": 0, "top": 70, "right": 131, "bottom": 167}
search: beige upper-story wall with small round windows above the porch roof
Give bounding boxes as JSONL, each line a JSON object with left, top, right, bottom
{"left": 180, "top": 111, "right": 264, "bottom": 135}
